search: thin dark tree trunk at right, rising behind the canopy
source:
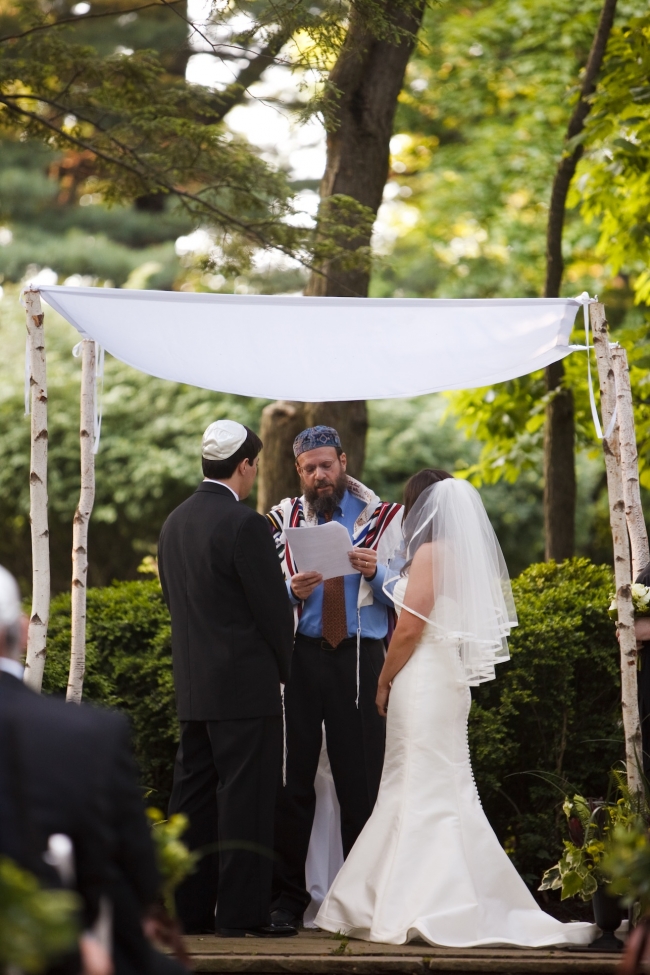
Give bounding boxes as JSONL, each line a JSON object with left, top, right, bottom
{"left": 544, "top": 0, "right": 616, "bottom": 561}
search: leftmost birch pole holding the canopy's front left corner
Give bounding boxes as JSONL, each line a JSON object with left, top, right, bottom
{"left": 24, "top": 290, "right": 50, "bottom": 693}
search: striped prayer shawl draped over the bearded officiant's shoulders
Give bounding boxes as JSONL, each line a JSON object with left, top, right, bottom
{"left": 266, "top": 477, "right": 403, "bottom": 636}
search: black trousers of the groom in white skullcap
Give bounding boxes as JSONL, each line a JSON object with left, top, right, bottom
{"left": 169, "top": 715, "right": 282, "bottom": 932}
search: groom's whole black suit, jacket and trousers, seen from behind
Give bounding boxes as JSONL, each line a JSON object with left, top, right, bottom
{"left": 158, "top": 481, "right": 293, "bottom": 931}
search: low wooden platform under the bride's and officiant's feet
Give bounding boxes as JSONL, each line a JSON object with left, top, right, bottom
{"left": 185, "top": 931, "right": 621, "bottom": 975}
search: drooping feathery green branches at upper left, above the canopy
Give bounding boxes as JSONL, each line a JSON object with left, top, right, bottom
{"left": 0, "top": 2, "right": 304, "bottom": 266}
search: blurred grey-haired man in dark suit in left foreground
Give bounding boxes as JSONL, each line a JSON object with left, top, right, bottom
{"left": 0, "top": 566, "right": 113, "bottom": 975}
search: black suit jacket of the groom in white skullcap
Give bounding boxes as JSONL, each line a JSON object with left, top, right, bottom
{"left": 158, "top": 481, "right": 293, "bottom": 721}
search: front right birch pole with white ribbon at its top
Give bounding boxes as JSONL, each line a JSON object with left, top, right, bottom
{"left": 589, "top": 303, "right": 642, "bottom": 794}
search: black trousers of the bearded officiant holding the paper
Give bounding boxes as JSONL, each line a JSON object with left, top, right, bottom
{"left": 273, "top": 633, "right": 386, "bottom": 916}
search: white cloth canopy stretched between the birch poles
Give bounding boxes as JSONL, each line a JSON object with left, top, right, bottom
{"left": 38, "top": 284, "right": 581, "bottom": 402}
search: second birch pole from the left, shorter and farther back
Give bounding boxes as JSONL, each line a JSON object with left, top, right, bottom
{"left": 66, "top": 339, "right": 97, "bottom": 704}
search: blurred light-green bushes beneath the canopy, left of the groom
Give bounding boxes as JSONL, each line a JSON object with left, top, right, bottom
{"left": 0, "top": 291, "right": 264, "bottom": 592}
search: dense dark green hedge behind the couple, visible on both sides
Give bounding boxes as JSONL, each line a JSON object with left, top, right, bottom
{"left": 40, "top": 559, "right": 622, "bottom": 886}
